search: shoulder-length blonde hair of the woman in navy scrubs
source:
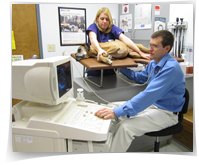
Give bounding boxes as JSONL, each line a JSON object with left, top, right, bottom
{"left": 93, "top": 7, "right": 113, "bottom": 33}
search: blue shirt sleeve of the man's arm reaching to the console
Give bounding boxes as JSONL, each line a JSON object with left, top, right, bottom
{"left": 113, "top": 65, "right": 177, "bottom": 117}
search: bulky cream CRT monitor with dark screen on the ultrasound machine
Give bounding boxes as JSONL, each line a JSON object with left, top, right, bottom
{"left": 12, "top": 56, "right": 73, "bottom": 105}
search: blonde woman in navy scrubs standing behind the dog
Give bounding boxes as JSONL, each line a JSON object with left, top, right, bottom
{"left": 86, "top": 7, "right": 150, "bottom": 76}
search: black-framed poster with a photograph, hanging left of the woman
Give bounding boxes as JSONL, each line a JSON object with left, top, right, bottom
{"left": 58, "top": 7, "right": 87, "bottom": 46}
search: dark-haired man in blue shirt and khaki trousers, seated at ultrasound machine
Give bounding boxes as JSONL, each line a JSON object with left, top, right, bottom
{"left": 95, "top": 30, "right": 185, "bottom": 152}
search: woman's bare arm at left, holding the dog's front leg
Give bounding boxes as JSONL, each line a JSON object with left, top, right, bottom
{"left": 89, "top": 31, "right": 107, "bottom": 60}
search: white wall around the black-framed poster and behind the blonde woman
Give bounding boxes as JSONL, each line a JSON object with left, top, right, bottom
{"left": 39, "top": 4, "right": 118, "bottom": 77}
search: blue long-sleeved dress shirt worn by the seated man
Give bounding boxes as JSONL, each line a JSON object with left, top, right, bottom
{"left": 113, "top": 53, "right": 186, "bottom": 117}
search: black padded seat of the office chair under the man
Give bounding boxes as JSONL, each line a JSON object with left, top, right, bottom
{"left": 145, "top": 123, "right": 183, "bottom": 136}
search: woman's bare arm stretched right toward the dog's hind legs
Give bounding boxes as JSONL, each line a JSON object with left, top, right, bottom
{"left": 119, "top": 33, "right": 150, "bottom": 60}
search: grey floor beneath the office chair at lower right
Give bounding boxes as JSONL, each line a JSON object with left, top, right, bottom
{"left": 138, "top": 139, "right": 193, "bottom": 152}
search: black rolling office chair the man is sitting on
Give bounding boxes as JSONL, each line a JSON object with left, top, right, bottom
{"left": 145, "top": 88, "right": 189, "bottom": 152}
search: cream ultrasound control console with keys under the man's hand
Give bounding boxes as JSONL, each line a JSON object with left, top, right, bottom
{"left": 27, "top": 99, "right": 111, "bottom": 141}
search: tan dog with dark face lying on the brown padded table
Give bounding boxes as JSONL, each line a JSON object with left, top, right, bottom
{"left": 75, "top": 40, "right": 149, "bottom": 65}
